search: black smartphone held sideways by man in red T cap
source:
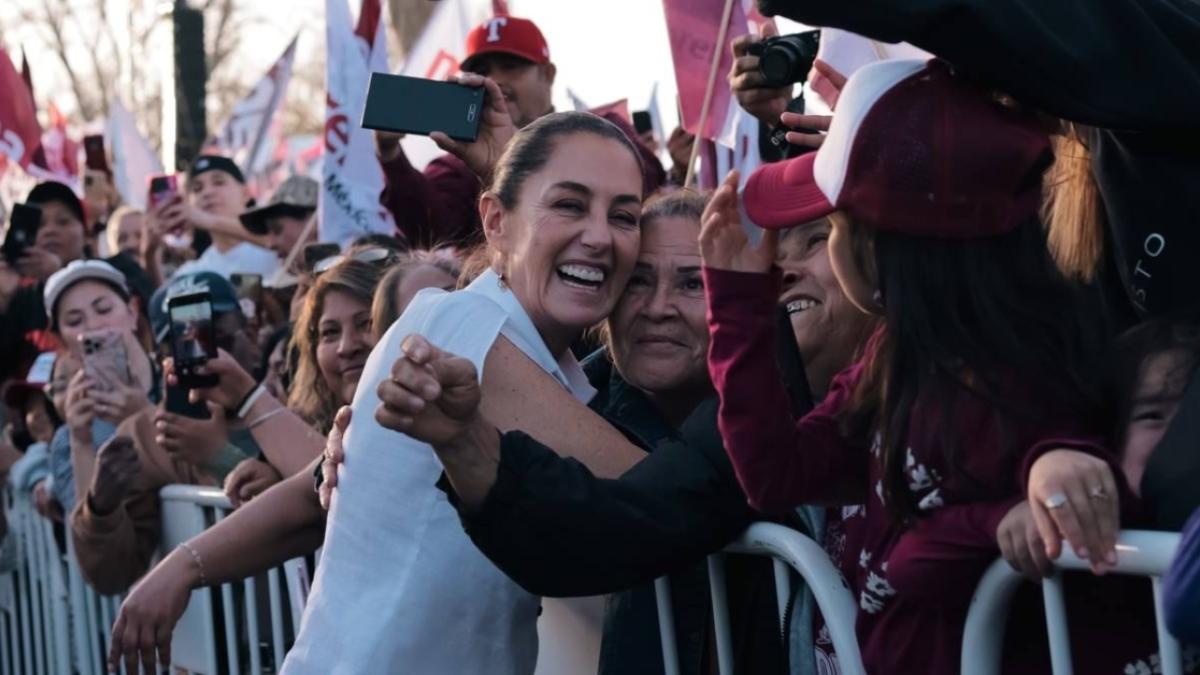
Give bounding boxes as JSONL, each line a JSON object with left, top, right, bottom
{"left": 362, "top": 72, "right": 484, "bottom": 141}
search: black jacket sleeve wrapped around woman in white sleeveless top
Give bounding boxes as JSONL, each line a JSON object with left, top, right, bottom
{"left": 442, "top": 401, "right": 754, "bottom": 597}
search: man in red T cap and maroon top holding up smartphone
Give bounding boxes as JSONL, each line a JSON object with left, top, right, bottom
{"left": 376, "top": 17, "right": 666, "bottom": 250}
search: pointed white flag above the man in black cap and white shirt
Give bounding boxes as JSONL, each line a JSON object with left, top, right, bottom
{"left": 216, "top": 35, "right": 299, "bottom": 178}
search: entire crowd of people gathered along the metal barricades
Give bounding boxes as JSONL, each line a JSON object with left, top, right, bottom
{"left": 0, "top": 5, "right": 1200, "bottom": 674}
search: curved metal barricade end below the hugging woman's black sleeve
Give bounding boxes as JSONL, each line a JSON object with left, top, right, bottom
{"left": 654, "top": 522, "right": 865, "bottom": 675}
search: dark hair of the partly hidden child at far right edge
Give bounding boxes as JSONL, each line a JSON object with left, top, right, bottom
{"left": 1108, "top": 306, "right": 1200, "bottom": 452}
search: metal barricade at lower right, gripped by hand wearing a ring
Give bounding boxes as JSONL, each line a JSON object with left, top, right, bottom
{"left": 962, "top": 530, "right": 1183, "bottom": 675}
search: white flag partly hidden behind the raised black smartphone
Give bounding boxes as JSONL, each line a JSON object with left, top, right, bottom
{"left": 398, "top": 0, "right": 492, "bottom": 169}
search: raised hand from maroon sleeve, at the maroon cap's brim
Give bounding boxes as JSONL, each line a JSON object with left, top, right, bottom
{"left": 700, "top": 171, "right": 779, "bottom": 274}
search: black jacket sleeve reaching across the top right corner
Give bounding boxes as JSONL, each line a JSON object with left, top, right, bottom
{"left": 760, "top": 0, "right": 1200, "bottom": 131}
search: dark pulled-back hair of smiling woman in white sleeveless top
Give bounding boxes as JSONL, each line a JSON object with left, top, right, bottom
{"left": 490, "top": 112, "right": 642, "bottom": 210}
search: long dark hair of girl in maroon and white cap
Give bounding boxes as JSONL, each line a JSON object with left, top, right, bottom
{"left": 841, "top": 220, "right": 1109, "bottom": 522}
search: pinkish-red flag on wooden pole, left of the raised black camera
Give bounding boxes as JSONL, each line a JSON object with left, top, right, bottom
{"left": 662, "top": 0, "right": 749, "bottom": 138}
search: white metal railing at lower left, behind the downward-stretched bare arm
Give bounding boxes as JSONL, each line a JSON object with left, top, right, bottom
{"left": 0, "top": 485, "right": 308, "bottom": 675}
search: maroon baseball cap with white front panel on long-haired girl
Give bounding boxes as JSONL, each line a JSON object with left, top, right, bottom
{"left": 743, "top": 60, "right": 1052, "bottom": 239}
